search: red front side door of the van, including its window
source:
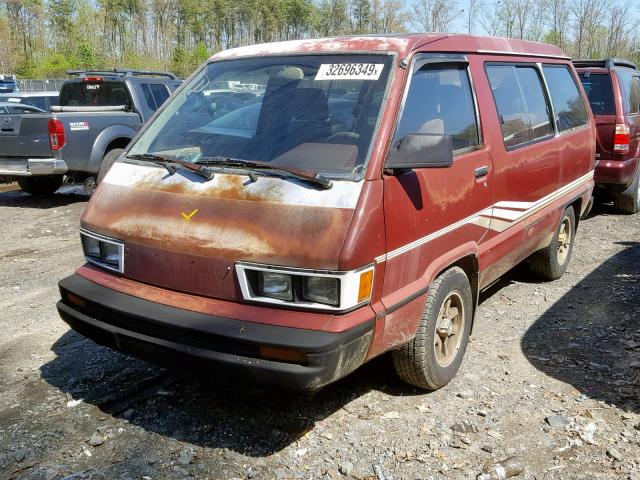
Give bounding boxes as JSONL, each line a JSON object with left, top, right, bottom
{"left": 382, "top": 56, "right": 493, "bottom": 316}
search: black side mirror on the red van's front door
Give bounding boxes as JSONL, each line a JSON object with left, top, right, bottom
{"left": 385, "top": 133, "right": 453, "bottom": 173}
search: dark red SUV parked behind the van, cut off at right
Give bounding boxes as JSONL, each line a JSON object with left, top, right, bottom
{"left": 573, "top": 58, "right": 640, "bottom": 213}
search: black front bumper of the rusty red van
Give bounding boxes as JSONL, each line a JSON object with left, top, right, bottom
{"left": 57, "top": 275, "right": 373, "bottom": 390}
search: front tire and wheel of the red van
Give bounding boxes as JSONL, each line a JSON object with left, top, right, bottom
{"left": 392, "top": 267, "right": 473, "bottom": 390}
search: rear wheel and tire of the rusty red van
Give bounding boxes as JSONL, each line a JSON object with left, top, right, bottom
{"left": 529, "top": 207, "right": 576, "bottom": 280}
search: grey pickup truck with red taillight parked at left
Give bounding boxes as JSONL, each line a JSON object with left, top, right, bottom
{"left": 0, "top": 70, "right": 181, "bottom": 195}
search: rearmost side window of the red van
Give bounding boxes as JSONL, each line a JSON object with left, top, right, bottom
{"left": 542, "top": 65, "right": 587, "bottom": 132}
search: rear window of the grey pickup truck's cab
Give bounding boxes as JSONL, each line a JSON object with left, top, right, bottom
{"left": 60, "top": 80, "right": 131, "bottom": 107}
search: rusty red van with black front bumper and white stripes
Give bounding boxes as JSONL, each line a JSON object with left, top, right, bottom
{"left": 58, "top": 34, "right": 595, "bottom": 390}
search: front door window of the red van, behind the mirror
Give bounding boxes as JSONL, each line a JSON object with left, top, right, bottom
{"left": 395, "top": 66, "right": 479, "bottom": 150}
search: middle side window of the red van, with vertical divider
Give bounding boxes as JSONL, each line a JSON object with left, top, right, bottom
{"left": 486, "top": 65, "right": 553, "bottom": 149}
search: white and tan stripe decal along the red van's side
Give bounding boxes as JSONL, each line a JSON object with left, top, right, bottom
{"left": 374, "top": 171, "right": 593, "bottom": 263}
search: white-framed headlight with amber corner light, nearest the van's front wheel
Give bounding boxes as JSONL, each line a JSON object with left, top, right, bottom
{"left": 236, "top": 262, "right": 374, "bottom": 311}
